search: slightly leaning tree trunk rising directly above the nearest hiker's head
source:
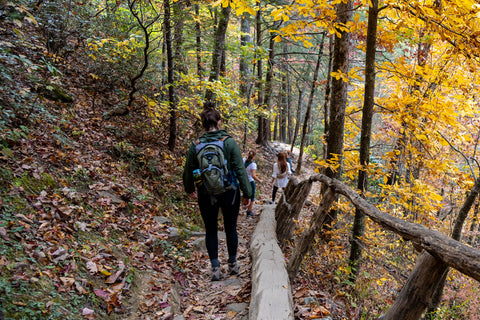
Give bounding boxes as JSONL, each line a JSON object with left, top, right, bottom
{"left": 205, "top": 6, "right": 231, "bottom": 102}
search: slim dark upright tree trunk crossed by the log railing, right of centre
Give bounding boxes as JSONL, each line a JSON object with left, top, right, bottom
{"left": 349, "top": 0, "right": 378, "bottom": 281}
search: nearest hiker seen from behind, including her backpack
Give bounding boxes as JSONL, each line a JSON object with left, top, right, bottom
{"left": 183, "top": 102, "right": 252, "bottom": 281}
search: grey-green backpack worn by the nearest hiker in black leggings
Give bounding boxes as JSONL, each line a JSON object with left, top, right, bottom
{"left": 195, "top": 136, "right": 234, "bottom": 195}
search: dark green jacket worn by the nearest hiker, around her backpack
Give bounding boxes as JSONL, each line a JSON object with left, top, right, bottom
{"left": 183, "top": 130, "right": 252, "bottom": 198}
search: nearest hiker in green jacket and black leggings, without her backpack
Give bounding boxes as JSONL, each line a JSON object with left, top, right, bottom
{"left": 183, "top": 102, "right": 252, "bottom": 281}
